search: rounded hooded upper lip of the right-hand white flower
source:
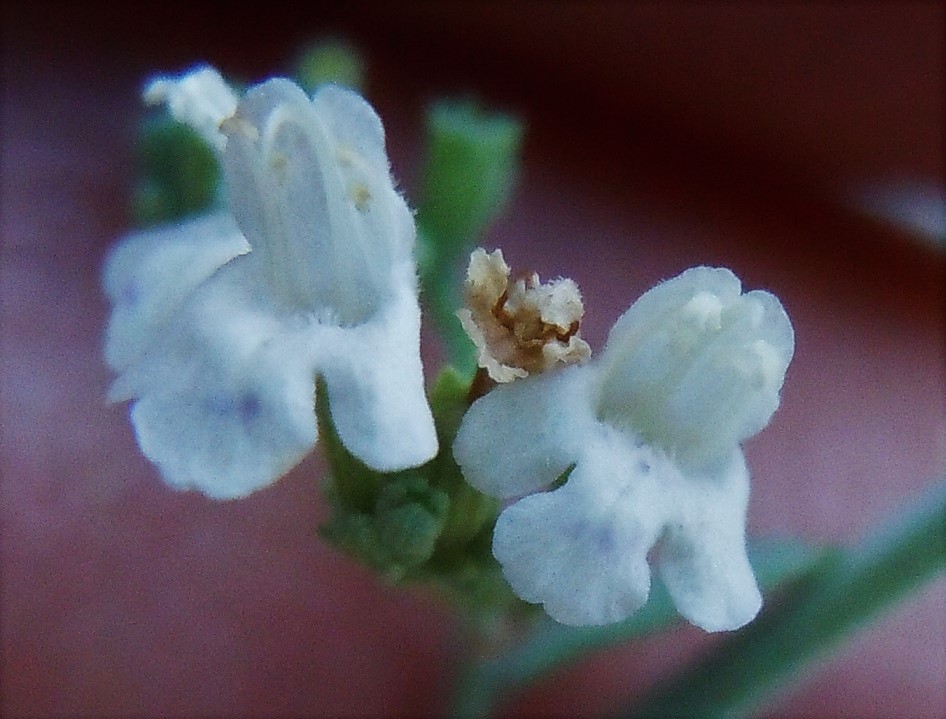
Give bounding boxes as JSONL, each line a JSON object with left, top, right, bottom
{"left": 598, "top": 267, "right": 794, "bottom": 469}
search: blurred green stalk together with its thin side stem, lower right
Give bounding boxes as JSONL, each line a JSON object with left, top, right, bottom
{"left": 450, "top": 481, "right": 946, "bottom": 719}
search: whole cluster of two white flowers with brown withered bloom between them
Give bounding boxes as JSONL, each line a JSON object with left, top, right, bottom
{"left": 104, "top": 67, "right": 794, "bottom": 631}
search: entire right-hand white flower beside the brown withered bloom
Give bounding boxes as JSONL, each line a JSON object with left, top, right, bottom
{"left": 453, "top": 267, "right": 794, "bottom": 631}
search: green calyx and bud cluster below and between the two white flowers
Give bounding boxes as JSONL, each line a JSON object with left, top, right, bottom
{"left": 316, "top": 366, "right": 524, "bottom": 624}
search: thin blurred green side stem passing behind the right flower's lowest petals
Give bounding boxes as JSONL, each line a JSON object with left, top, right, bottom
{"left": 449, "top": 540, "right": 824, "bottom": 717}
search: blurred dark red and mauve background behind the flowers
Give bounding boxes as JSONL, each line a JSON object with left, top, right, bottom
{"left": 0, "top": 3, "right": 946, "bottom": 719}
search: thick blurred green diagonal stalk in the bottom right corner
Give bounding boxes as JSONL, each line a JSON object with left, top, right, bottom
{"left": 626, "top": 482, "right": 946, "bottom": 719}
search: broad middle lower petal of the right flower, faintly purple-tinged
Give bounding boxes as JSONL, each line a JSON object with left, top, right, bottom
{"left": 493, "top": 432, "right": 673, "bottom": 626}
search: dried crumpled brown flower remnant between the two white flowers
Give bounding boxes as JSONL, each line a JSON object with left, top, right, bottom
{"left": 458, "top": 248, "right": 591, "bottom": 382}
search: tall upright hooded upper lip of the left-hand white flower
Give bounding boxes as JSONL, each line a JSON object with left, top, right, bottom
{"left": 223, "top": 80, "right": 414, "bottom": 325}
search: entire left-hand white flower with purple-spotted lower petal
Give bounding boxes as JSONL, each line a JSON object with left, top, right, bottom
{"left": 104, "top": 68, "right": 437, "bottom": 499}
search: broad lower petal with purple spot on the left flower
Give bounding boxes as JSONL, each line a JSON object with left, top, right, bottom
{"left": 117, "top": 254, "right": 324, "bottom": 499}
